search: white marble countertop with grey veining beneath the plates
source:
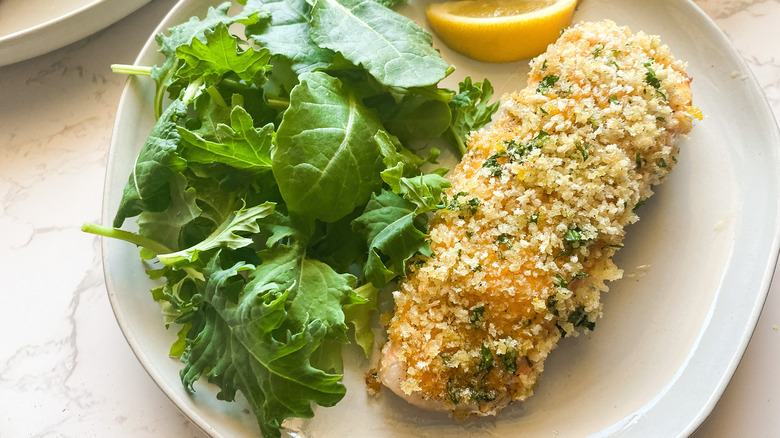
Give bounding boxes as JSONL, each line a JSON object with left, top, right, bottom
{"left": 0, "top": 0, "right": 780, "bottom": 438}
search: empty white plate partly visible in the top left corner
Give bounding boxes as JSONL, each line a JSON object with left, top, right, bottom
{"left": 0, "top": 0, "right": 150, "bottom": 66}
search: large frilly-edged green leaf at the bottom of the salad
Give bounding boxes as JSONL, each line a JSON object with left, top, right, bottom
{"left": 181, "top": 250, "right": 362, "bottom": 437}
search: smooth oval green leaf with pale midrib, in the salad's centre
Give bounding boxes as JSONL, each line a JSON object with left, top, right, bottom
{"left": 273, "top": 72, "right": 384, "bottom": 222}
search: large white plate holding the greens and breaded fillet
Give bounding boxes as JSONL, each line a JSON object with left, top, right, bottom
{"left": 103, "top": 0, "right": 780, "bottom": 438}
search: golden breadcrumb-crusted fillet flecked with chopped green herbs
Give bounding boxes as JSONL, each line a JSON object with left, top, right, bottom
{"left": 379, "top": 21, "right": 701, "bottom": 415}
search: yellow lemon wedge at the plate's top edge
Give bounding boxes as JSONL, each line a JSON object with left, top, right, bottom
{"left": 425, "top": 0, "right": 577, "bottom": 62}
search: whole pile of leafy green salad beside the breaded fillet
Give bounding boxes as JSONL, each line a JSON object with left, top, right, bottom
{"left": 83, "top": 0, "right": 497, "bottom": 437}
